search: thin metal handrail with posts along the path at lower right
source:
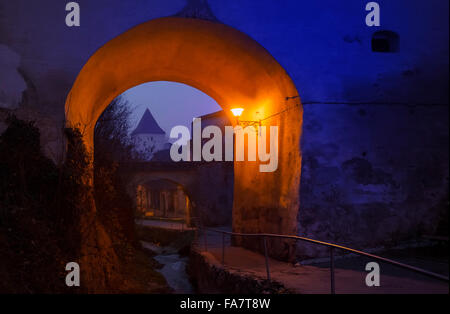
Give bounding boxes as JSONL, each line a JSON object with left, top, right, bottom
{"left": 199, "top": 226, "right": 449, "bottom": 294}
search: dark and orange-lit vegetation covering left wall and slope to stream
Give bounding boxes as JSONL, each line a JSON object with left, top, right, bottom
{"left": 0, "top": 116, "right": 168, "bottom": 293}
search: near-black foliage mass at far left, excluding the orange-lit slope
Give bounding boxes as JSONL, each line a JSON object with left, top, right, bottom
{"left": 0, "top": 116, "right": 89, "bottom": 293}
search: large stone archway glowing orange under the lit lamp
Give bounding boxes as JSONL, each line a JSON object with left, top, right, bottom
{"left": 65, "top": 17, "right": 303, "bottom": 259}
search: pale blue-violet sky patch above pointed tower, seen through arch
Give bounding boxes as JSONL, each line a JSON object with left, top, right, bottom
{"left": 122, "top": 82, "right": 221, "bottom": 136}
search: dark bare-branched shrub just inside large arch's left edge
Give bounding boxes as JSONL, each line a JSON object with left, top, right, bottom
{"left": 94, "top": 98, "right": 135, "bottom": 244}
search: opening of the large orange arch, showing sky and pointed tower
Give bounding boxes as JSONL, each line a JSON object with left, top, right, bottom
{"left": 94, "top": 82, "right": 234, "bottom": 228}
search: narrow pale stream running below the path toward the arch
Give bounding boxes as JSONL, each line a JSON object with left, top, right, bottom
{"left": 141, "top": 241, "right": 194, "bottom": 294}
